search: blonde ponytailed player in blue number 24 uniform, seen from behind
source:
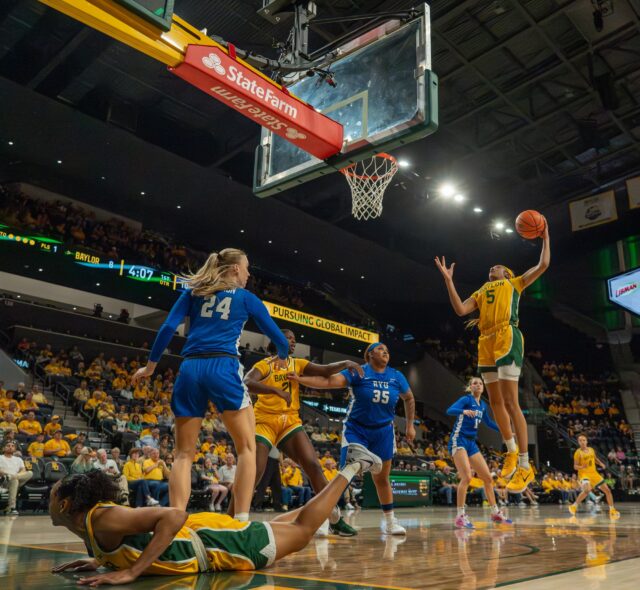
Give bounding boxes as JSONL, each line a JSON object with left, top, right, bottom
{"left": 132, "top": 248, "right": 289, "bottom": 520}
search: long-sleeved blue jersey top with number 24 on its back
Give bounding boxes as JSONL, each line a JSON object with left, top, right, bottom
{"left": 149, "top": 289, "right": 289, "bottom": 362}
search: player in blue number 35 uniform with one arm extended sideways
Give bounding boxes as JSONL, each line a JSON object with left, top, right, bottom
{"left": 289, "top": 342, "right": 416, "bottom": 535}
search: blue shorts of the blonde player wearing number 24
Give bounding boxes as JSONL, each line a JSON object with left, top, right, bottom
{"left": 171, "top": 356, "right": 251, "bottom": 418}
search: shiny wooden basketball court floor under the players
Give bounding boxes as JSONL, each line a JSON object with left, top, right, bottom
{"left": 0, "top": 504, "right": 640, "bottom": 590}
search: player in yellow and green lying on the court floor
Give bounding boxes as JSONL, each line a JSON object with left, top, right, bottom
{"left": 49, "top": 444, "right": 382, "bottom": 587}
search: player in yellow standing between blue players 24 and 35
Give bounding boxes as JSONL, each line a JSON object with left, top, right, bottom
{"left": 244, "top": 330, "right": 362, "bottom": 537}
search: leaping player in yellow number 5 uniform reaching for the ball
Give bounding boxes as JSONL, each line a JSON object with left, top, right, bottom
{"left": 435, "top": 220, "right": 551, "bottom": 494}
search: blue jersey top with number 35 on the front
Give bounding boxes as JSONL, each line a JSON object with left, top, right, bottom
{"left": 340, "top": 364, "right": 409, "bottom": 428}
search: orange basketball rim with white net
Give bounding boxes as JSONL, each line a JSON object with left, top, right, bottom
{"left": 340, "top": 153, "right": 398, "bottom": 221}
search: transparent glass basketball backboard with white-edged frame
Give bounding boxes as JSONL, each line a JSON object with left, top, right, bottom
{"left": 254, "top": 4, "right": 438, "bottom": 197}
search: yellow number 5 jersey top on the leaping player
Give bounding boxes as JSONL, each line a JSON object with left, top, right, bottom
{"left": 471, "top": 276, "right": 524, "bottom": 335}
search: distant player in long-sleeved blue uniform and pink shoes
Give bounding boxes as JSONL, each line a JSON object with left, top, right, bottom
{"left": 447, "top": 377, "right": 511, "bottom": 529}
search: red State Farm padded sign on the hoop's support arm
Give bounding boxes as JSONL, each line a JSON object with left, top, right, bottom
{"left": 169, "top": 45, "right": 343, "bottom": 160}
